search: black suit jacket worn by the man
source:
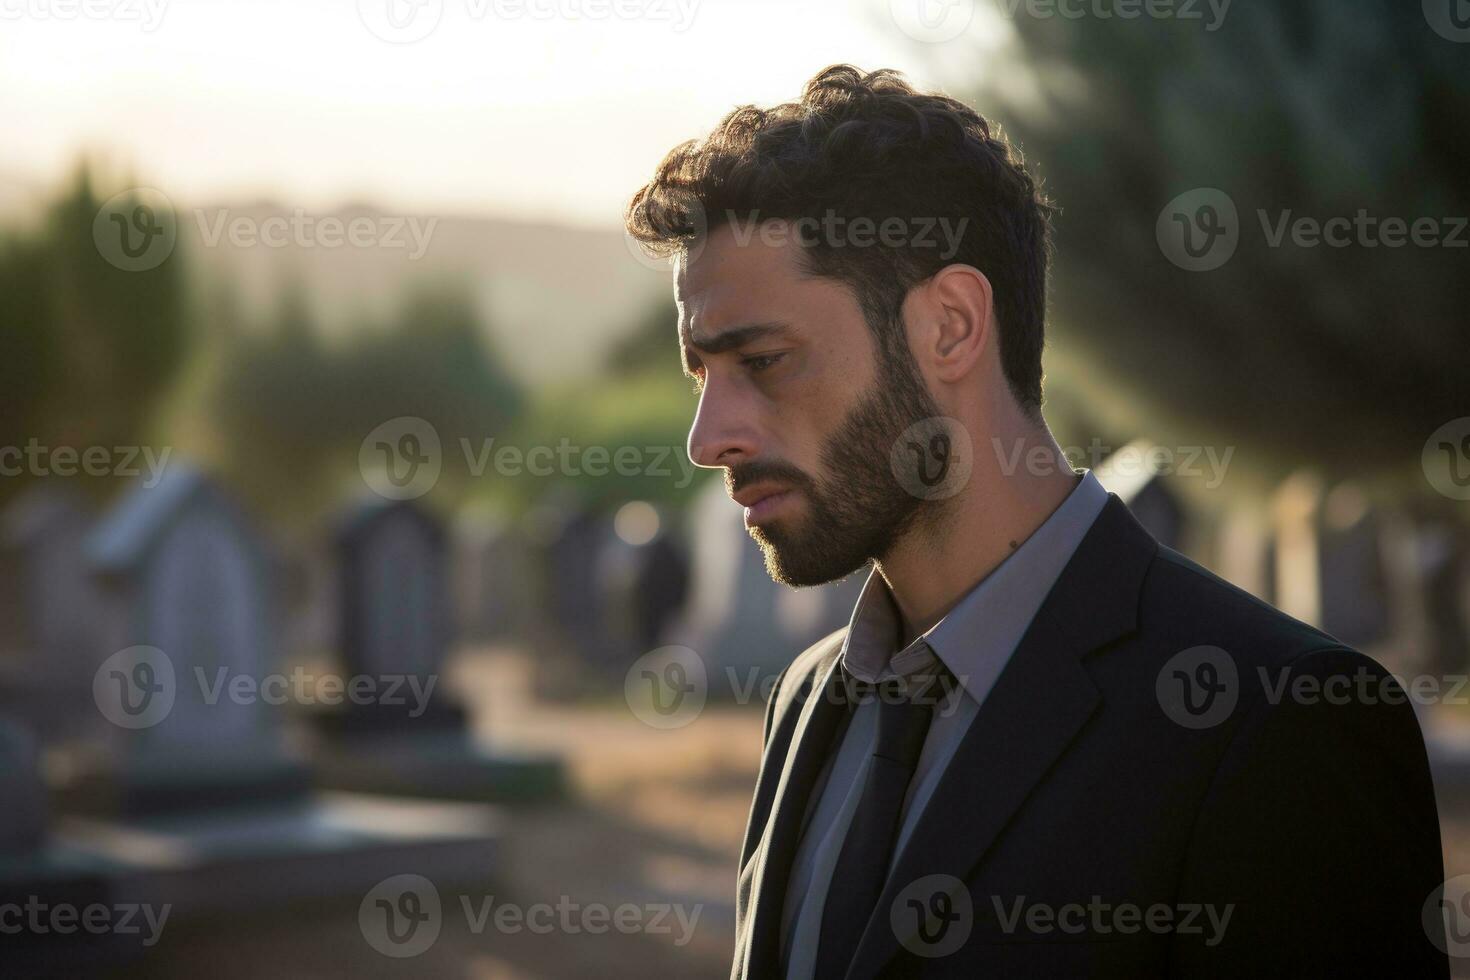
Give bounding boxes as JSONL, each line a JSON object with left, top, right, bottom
{"left": 732, "top": 497, "right": 1448, "bottom": 980}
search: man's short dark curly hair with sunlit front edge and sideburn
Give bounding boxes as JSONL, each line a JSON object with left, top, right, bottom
{"left": 623, "top": 65, "right": 1053, "bottom": 417}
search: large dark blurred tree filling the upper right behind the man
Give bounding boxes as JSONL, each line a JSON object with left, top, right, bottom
{"left": 980, "top": 0, "right": 1470, "bottom": 473}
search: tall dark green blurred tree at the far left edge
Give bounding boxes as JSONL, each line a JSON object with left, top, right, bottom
{"left": 0, "top": 165, "right": 193, "bottom": 492}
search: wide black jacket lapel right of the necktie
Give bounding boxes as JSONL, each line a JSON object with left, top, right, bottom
{"left": 848, "top": 495, "right": 1158, "bottom": 980}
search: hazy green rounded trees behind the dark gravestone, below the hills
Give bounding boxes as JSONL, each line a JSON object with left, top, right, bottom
{"left": 209, "top": 288, "right": 522, "bottom": 519}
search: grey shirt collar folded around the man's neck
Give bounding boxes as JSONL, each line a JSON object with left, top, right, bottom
{"left": 841, "top": 472, "right": 1108, "bottom": 701}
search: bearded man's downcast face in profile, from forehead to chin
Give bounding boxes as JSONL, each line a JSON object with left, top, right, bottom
{"left": 675, "top": 226, "right": 941, "bottom": 585}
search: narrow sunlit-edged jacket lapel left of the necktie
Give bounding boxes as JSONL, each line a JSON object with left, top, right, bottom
{"left": 741, "top": 642, "right": 847, "bottom": 977}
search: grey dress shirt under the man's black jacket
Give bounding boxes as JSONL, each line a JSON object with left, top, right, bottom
{"left": 782, "top": 473, "right": 1107, "bottom": 980}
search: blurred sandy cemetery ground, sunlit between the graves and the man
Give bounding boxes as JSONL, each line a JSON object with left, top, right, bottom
{"left": 83, "top": 648, "right": 1470, "bottom": 980}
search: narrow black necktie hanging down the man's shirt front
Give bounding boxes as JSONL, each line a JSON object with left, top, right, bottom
{"left": 816, "top": 669, "right": 933, "bottom": 980}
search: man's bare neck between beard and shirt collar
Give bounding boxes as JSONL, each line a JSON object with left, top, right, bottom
{"left": 875, "top": 423, "right": 1078, "bottom": 645}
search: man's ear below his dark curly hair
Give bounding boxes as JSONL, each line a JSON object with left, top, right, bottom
{"left": 908, "top": 264, "right": 995, "bottom": 383}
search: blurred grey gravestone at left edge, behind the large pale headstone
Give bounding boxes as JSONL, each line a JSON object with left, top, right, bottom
{"left": 0, "top": 482, "right": 103, "bottom": 741}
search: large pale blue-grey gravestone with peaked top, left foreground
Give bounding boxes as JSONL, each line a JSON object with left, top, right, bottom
{"left": 68, "top": 466, "right": 309, "bottom": 813}
